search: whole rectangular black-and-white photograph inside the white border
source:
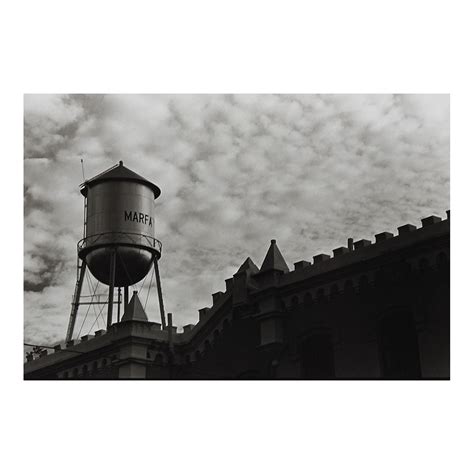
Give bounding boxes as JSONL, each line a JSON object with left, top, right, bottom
{"left": 25, "top": 94, "right": 450, "bottom": 380}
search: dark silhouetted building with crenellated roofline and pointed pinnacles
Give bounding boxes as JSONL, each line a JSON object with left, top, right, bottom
{"left": 24, "top": 211, "right": 450, "bottom": 380}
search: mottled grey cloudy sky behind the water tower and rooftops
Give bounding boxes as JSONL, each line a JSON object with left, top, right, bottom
{"left": 24, "top": 94, "right": 450, "bottom": 345}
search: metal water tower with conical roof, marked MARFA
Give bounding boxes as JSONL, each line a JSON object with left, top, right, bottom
{"left": 66, "top": 161, "right": 165, "bottom": 341}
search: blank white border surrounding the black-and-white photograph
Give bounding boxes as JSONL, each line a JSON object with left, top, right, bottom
{"left": 0, "top": 0, "right": 474, "bottom": 474}
